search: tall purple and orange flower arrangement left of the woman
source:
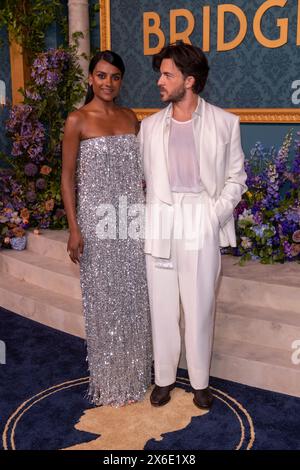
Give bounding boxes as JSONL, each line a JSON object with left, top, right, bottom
{"left": 0, "top": 47, "right": 85, "bottom": 247}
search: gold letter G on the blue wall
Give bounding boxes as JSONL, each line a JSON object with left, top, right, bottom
{"left": 253, "top": 0, "right": 289, "bottom": 49}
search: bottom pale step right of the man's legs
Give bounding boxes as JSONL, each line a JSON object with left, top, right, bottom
{"left": 211, "top": 338, "right": 300, "bottom": 397}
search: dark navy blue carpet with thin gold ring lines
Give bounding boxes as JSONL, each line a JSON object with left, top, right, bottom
{"left": 0, "top": 308, "right": 300, "bottom": 451}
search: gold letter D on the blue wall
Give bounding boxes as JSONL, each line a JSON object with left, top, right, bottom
{"left": 217, "top": 3, "right": 247, "bottom": 51}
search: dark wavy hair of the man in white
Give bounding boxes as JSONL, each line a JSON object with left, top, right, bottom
{"left": 152, "top": 42, "right": 209, "bottom": 95}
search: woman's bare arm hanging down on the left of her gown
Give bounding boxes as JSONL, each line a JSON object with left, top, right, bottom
{"left": 61, "top": 111, "right": 83, "bottom": 263}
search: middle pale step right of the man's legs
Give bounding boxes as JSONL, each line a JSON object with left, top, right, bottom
{"left": 215, "top": 302, "right": 300, "bottom": 351}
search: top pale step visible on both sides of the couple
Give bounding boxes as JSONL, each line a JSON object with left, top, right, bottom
{"left": 27, "top": 230, "right": 300, "bottom": 313}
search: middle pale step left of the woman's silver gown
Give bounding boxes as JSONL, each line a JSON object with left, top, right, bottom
{"left": 0, "top": 250, "right": 81, "bottom": 300}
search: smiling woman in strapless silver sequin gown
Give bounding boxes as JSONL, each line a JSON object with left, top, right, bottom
{"left": 62, "top": 51, "right": 152, "bottom": 406}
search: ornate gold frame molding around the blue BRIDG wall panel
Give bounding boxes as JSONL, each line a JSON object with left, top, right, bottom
{"left": 99, "top": 0, "right": 300, "bottom": 124}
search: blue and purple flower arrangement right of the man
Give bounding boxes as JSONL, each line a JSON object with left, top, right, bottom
{"left": 234, "top": 131, "right": 300, "bottom": 264}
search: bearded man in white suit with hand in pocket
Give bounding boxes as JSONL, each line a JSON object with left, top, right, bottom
{"left": 139, "top": 43, "right": 246, "bottom": 409}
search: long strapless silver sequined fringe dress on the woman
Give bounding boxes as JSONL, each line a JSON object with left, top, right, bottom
{"left": 77, "top": 134, "right": 152, "bottom": 406}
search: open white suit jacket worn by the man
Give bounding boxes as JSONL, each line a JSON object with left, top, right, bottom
{"left": 139, "top": 97, "right": 247, "bottom": 258}
